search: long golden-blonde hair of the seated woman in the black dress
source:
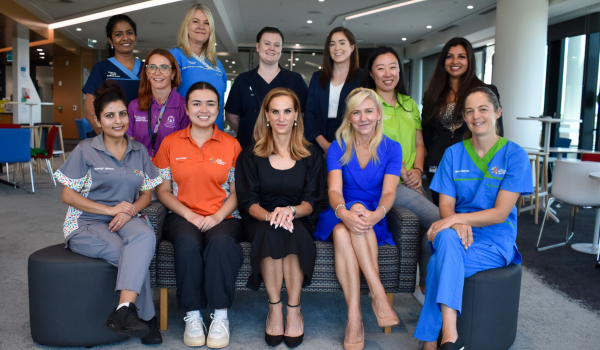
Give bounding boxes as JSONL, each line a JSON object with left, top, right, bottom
{"left": 254, "top": 87, "right": 310, "bottom": 160}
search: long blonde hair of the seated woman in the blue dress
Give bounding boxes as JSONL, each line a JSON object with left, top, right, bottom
{"left": 335, "top": 88, "right": 383, "bottom": 165}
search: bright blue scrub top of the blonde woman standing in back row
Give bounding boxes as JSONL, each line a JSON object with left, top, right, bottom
{"left": 169, "top": 47, "right": 227, "bottom": 131}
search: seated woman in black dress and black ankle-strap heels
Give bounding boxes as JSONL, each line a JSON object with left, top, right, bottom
{"left": 235, "top": 88, "right": 326, "bottom": 347}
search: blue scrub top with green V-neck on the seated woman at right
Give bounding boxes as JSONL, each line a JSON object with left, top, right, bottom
{"left": 429, "top": 137, "right": 533, "bottom": 264}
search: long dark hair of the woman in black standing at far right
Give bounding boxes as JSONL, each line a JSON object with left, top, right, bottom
{"left": 423, "top": 37, "right": 486, "bottom": 123}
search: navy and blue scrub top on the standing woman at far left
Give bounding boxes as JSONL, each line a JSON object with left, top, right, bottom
{"left": 81, "top": 57, "right": 142, "bottom": 106}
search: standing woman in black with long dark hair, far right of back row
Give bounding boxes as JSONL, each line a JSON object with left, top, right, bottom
{"left": 423, "top": 38, "right": 502, "bottom": 205}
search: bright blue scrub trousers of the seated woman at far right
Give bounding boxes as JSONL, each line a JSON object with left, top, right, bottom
{"left": 414, "top": 228, "right": 512, "bottom": 341}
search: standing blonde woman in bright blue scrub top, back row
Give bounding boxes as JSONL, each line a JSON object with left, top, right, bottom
{"left": 169, "top": 4, "right": 227, "bottom": 131}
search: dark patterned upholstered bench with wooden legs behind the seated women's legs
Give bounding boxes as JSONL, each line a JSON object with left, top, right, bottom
{"left": 142, "top": 200, "right": 419, "bottom": 333}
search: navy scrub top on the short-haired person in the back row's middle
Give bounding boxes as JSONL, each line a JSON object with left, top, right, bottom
{"left": 225, "top": 65, "right": 308, "bottom": 148}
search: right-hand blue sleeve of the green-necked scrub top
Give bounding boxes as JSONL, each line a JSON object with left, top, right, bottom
{"left": 500, "top": 146, "right": 533, "bottom": 195}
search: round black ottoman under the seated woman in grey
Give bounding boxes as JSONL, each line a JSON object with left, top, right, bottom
{"left": 28, "top": 244, "right": 128, "bottom": 347}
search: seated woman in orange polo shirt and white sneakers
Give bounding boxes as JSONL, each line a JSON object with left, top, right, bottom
{"left": 154, "top": 82, "right": 243, "bottom": 348}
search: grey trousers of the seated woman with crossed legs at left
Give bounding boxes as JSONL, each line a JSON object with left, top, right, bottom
{"left": 68, "top": 216, "right": 156, "bottom": 320}
